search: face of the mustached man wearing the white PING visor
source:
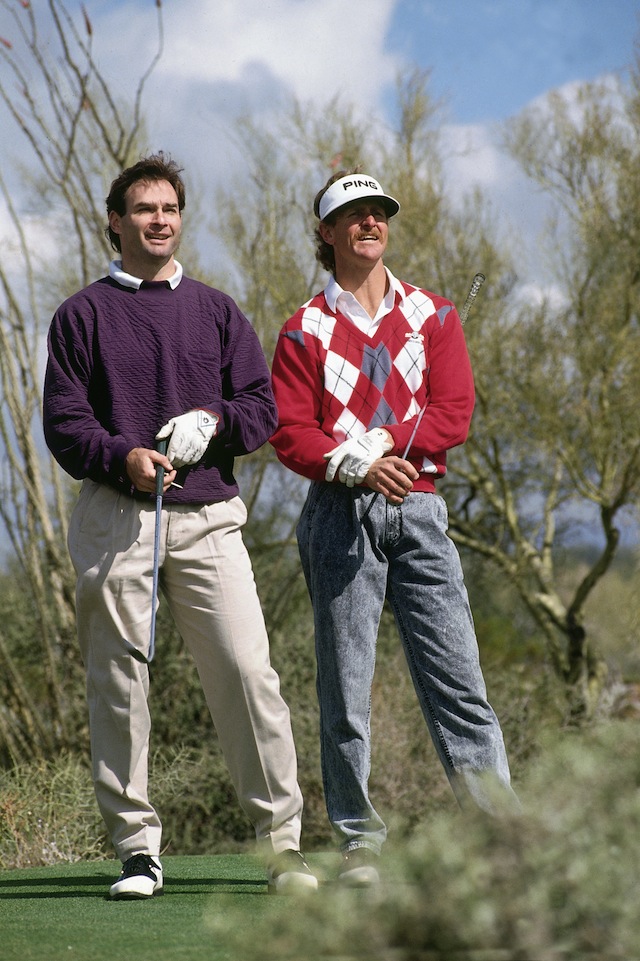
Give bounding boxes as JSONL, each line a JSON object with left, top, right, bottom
{"left": 320, "top": 200, "right": 389, "bottom": 269}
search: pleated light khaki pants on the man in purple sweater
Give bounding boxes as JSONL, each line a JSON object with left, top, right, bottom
{"left": 69, "top": 480, "right": 302, "bottom": 861}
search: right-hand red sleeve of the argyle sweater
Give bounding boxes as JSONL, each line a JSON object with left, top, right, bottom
{"left": 387, "top": 304, "right": 475, "bottom": 457}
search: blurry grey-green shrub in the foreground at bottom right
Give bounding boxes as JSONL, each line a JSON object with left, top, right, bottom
{"left": 208, "top": 722, "right": 640, "bottom": 961}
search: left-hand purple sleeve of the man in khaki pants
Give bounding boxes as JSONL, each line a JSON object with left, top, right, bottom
{"left": 43, "top": 305, "right": 135, "bottom": 487}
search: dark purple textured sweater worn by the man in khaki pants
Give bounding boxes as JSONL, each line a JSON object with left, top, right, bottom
{"left": 43, "top": 277, "right": 277, "bottom": 504}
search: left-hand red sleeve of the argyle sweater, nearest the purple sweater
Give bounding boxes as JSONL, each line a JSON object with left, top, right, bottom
{"left": 271, "top": 324, "right": 336, "bottom": 480}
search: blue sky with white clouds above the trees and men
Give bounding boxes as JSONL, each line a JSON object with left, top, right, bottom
{"left": 0, "top": 0, "right": 640, "bottom": 272}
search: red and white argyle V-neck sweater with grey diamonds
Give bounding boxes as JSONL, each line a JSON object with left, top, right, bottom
{"left": 271, "top": 283, "right": 475, "bottom": 491}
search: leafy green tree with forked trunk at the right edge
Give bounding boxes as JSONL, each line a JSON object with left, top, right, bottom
{"left": 444, "top": 71, "right": 640, "bottom": 716}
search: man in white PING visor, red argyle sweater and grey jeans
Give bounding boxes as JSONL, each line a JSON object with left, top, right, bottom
{"left": 271, "top": 171, "right": 518, "bottom": 886}
